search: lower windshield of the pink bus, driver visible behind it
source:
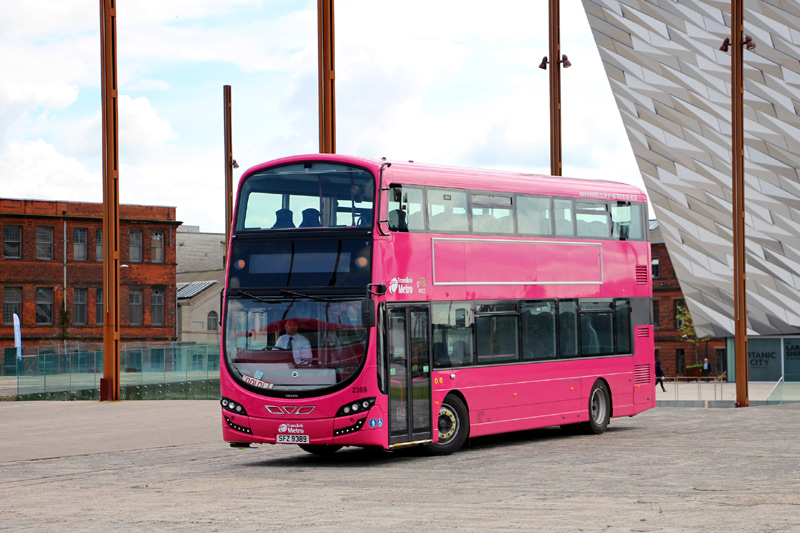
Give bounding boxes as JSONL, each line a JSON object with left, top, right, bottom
{"left": 225, "top": 293, "right": 368, "bottom": 395}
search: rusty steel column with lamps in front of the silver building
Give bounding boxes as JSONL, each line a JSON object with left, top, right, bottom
{"left": 731, "top": 0, "right": 750, "bottom": 407}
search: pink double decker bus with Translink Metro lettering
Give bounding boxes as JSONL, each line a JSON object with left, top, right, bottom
{"left": 220, "top": 154, "right": 655, "bottom": 454}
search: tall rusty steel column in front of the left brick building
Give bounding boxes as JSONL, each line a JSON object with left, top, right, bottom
{"left": 100, "top": 0, "right": 120, "bottom": 401}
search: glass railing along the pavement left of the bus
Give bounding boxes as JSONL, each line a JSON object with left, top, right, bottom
{"left": 0, "top": 342, "right": 219, "bottom": 400}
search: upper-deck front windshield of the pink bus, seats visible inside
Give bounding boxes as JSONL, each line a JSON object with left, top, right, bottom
{"left": 236, "top": 161, "right": 375, "bottom": 231}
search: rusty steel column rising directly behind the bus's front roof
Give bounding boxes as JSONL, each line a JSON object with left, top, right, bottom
{"left": 317, "top": 0, "right": 336, "bottom": 154}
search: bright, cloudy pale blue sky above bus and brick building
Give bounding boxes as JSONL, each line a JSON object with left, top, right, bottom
{"left": 0, "top": 0, "right": 642, "bottom": 232}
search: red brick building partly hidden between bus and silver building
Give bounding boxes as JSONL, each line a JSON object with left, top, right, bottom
{"left": 650, "top": 220, "right": 727, "bottom": 376}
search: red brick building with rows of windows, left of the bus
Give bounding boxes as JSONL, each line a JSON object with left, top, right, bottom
{"left": 0, "top": 198, "right": 181, "bottom": 348}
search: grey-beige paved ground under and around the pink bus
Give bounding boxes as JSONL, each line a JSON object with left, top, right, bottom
{"left": 0, "top": 401, "right": 800, "bottom": 532}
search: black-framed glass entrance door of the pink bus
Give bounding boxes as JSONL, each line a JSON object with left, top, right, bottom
{"left": 386, "top": 304, "right": 433, "bottom": 446}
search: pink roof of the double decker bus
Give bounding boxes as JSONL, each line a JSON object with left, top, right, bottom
{"left": 243, "top": 154, "right": 647, "bottom": 202}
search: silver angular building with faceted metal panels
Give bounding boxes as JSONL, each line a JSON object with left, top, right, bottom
{"left": 582, "top": 0, "right": 800, "bottom": 379}
